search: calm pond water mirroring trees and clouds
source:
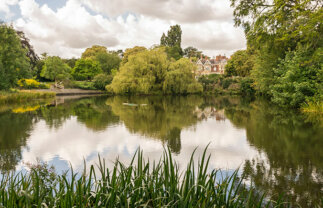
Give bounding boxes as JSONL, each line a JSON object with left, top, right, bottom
{"left": 0, "top": 96, "right": 323, "bottom": 206}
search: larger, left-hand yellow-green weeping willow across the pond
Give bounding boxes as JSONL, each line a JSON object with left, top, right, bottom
{"left": 108, "top": 48, "right": 169, "bottom": 94}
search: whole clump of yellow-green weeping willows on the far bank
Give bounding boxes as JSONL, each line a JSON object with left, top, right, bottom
{"left": 107, "top": 48, "right": 202, "bottom": 94}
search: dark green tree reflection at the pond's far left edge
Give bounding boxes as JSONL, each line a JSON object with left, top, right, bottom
{"left": 0, "top": 112, "right": 34, "bottom": 171}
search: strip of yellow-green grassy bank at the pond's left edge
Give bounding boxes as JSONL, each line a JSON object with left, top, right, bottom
{"left": 0, "top": 90, "right": 55, "bottom": 104}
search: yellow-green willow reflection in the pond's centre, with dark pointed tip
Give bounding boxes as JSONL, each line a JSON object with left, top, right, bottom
{"left": 106, "top": 96, "right": 203, "bottom": 153}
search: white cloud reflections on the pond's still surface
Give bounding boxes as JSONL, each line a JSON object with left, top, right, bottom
{"left": 22, "top": 117, "right": 259, "bottom": 172}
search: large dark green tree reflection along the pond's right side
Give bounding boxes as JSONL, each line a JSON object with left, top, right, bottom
{"left": 226, "top": 101, "right": 323, "bottom": 207}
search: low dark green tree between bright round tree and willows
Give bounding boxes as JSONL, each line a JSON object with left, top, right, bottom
{"left": 72, "top": 59, "right": 102, "bottom": 80}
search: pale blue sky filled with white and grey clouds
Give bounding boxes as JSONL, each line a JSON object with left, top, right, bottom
{"left": 0, "top": 0, "right": 246, "bottom": 58}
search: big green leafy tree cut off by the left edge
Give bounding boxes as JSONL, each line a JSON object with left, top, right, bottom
{"left": 0, "top": 22, "right": 31, "bottom": 90}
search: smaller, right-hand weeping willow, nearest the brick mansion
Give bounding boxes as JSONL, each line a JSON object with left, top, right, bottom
{"left": 163, "top": 58, "right": 203, "bottom": 94}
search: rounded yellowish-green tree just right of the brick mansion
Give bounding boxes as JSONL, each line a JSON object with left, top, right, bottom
{"left": 224, "top": 50, "right": 254, "bottom": 77}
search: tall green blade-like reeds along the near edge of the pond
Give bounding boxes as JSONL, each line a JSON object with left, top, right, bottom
{"left": 0, "top": 147, "right": 288, "bottom": 207}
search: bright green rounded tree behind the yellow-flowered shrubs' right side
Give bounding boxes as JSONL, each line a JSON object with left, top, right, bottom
{"left": 40, "top": 56, "right": 71, "bottom": 82}
